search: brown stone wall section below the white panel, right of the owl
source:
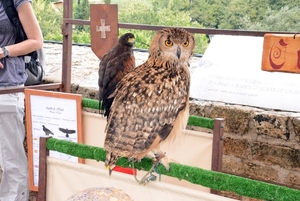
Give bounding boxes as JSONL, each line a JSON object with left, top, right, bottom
{"left": 190, "top": 101, "right": 300, "bottom": 199}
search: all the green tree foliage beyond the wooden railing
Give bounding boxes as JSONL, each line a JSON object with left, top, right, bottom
{"left": 33, "top": 0, "right": 300, "bottom": 53}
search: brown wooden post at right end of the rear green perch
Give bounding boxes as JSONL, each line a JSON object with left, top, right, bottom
{"left": 210, "top": 118, "right": 225, "bottom": 194}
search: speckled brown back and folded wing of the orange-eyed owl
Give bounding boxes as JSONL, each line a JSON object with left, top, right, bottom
{"left": 104, "top": 64, "right": 189, "bottom": 157}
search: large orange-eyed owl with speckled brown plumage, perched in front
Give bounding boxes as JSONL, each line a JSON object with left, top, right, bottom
{"left": 104, "top": 28, "right": 195, "bottom": 178}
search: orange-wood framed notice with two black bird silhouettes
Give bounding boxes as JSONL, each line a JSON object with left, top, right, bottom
{"left": 24, "top": 89, "right": 83, "bottom": 191}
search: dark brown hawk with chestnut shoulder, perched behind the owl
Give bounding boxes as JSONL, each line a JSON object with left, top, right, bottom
{"left": 98, "top": 33, "right": 135, "bottom": 117}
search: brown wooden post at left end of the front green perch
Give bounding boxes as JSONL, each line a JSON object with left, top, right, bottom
{"left": 37, "top": 136, "right": 51, "bottom": 201}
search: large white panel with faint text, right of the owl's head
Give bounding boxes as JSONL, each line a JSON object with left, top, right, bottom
{"left": 190, "top": 35, "right": 300, "bottom": 112}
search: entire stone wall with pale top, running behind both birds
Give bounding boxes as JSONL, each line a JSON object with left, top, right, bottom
{"left": 44, "top": 44, "right": 300, "bottom": 200}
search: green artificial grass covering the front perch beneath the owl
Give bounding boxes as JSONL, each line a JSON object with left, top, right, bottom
{"left": 46, "top": 138, "right": 300, "bottom": 201}
